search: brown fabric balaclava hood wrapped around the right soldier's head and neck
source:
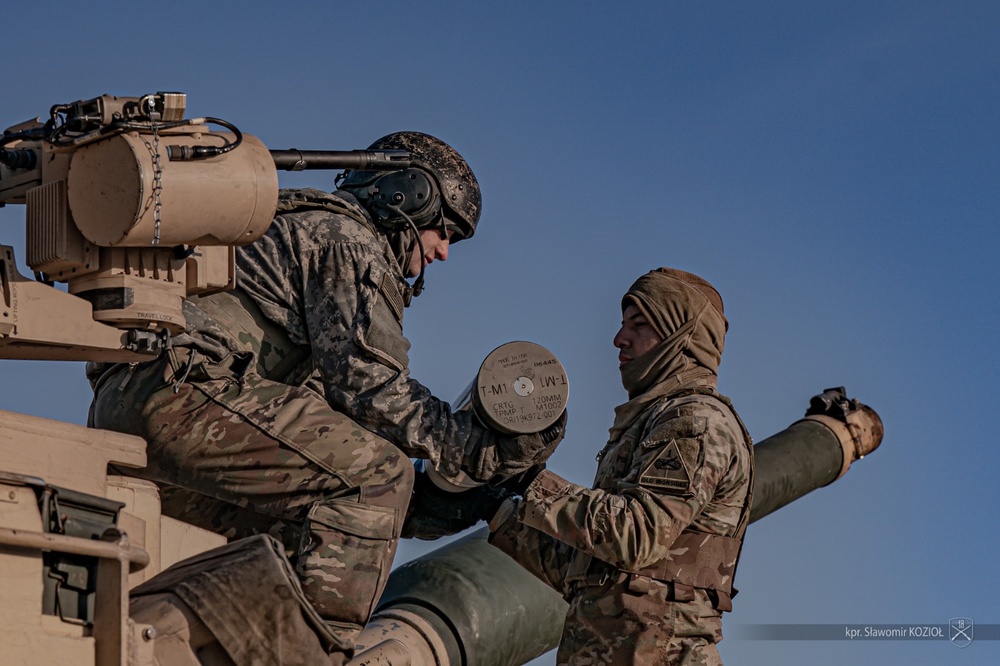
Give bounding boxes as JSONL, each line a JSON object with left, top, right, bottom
{"left": 611, "top": 268, "right": 729, "bottom": 438}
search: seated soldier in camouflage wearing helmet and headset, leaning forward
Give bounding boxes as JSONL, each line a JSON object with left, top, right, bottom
{"left": 88, "top": 132, "right": 562, "bottom": 663}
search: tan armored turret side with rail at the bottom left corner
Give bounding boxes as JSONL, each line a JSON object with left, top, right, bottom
{"left": 0, "top": 411, "right": 226, "bottom": 666}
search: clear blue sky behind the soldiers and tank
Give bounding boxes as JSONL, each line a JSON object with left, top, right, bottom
{"left": 0, "top": 0, "right": 1000, "bottom": 666}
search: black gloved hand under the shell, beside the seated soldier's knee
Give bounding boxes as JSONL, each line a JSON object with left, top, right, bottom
{"left": 401, "top": 464, "right": 510, "bottom": 540}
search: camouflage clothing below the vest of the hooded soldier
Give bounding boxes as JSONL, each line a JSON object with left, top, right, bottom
{"left": 556, "top": 573, "right": 722, "bottom": 666}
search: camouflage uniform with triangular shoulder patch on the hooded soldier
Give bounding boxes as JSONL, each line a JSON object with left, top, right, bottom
{"left": 491, "top": 268, "right": 753, "bottom": 665}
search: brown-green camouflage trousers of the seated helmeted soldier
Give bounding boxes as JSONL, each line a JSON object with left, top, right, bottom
{"left": 90, "top": 349, "right": 414, "bottom": 658}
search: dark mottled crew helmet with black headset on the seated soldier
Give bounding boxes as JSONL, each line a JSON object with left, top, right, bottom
{"left": 339, "top": 132, "right": 482, "bottom": 244}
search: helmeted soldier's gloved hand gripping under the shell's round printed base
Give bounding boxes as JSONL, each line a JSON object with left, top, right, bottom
{"left": 462, "top": 412, "right": 567, "bottom": 483}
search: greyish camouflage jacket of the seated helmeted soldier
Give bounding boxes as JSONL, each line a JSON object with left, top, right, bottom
{"left": 174, "top": 189, "right": 471, "bottom": 472}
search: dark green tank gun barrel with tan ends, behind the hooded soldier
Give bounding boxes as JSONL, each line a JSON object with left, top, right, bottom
{"left": 351, "top": 388, "right": 883, "bottom": 666}
